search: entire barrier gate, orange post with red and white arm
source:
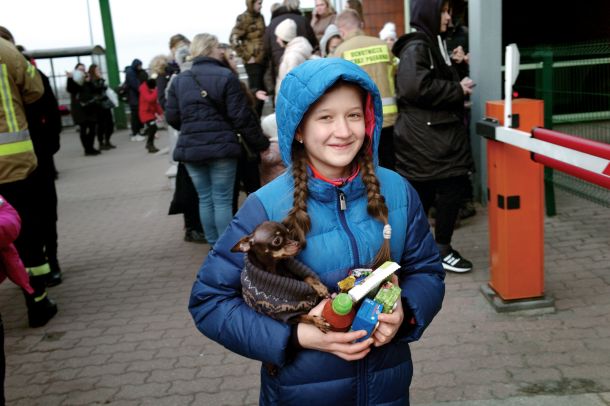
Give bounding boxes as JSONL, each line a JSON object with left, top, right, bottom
{"left": 477, "top": 44, "right": 610, "bottom": 312}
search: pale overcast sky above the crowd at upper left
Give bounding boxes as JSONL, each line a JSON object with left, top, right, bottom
{"left": 0, "top": 0, "right": 314, "bottom": 79}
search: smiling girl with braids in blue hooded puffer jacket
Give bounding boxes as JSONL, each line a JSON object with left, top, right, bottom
{"left": 189, "top": 58, "right": 444, "bottom": 406}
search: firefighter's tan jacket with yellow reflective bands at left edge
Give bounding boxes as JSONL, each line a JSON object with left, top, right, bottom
{"left": 0, "top": 38, "right": 44, "bottom": 184}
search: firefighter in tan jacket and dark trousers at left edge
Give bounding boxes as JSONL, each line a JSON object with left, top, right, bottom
{"left": 0, "top": 27, "right": 57, "bottom": 327}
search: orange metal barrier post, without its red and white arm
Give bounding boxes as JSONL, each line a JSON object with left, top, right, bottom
{"left": 482, "top": 99, "right": 548, "bottom": 311}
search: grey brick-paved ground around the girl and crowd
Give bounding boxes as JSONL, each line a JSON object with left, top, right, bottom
{"left": 0, "top": 130, "right": 610, "bottom": 406}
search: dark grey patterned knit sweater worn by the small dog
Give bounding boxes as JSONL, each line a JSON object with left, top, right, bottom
{"left": 241, "top": 255, "right": 319, "bottom": 322}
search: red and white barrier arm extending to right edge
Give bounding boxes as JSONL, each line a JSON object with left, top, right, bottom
{"left": 490, "top": 126, "right": 610, "bottom": 189}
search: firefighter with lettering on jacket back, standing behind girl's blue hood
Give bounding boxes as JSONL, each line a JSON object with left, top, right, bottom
{"left": 333, "top": 9, "right": 398, "bottom": 170}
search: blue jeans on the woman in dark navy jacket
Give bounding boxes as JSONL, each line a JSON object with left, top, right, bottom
{"left": 184, "top": 159, "right": 237, "bottom": 245}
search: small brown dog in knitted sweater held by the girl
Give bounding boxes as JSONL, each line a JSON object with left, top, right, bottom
{"left": 231, "top": 221, "right": 330, "bottom": 333}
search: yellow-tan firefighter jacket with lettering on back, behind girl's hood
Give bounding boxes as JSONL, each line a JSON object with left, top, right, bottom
{"left": 333, "top": 32, "right": 398, "bottom": 128}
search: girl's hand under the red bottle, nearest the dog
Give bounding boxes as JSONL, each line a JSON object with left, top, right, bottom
{"left": 297, "top": 299, "right": 373, "bottom": 361}
